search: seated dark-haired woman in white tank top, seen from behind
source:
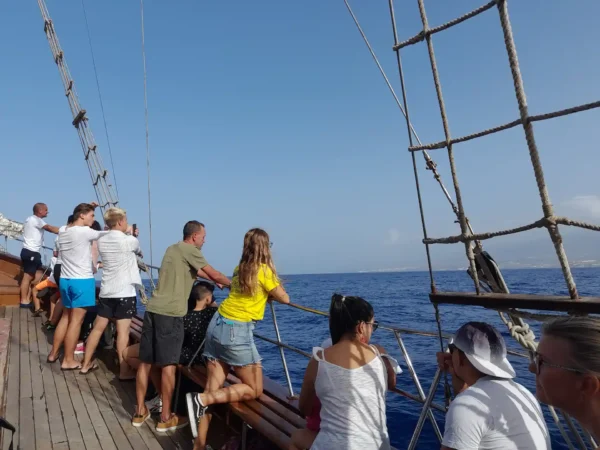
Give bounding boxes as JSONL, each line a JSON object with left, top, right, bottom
{"left": 292, "top": 294, "right": 396, "bottom": 450}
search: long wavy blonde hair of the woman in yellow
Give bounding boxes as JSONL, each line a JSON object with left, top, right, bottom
{"left": 232, "top": 228, "right": 279, "bottom": 295}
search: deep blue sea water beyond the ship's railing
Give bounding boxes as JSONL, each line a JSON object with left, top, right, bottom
{"left": 143, "top": 269, "right": 600, "bottom": 449}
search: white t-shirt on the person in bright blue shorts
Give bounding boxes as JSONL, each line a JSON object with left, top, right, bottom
{"left": 58, "top": 226, "right": 108, "bottom": 279}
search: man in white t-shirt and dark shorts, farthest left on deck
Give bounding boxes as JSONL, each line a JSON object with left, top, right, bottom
{"left": 21, "top": 203, "right": 58, "bottom": 315}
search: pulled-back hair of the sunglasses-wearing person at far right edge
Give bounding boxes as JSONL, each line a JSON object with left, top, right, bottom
{"left": 542, "top": 316, "right": 600, "bottom": 377}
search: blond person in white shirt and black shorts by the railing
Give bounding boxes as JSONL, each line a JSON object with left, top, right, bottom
{"left": 79, "top": 208, "right": 142, "bottom": 375}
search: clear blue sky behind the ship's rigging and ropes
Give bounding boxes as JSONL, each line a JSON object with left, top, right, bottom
{"left": 0, "top": 0, "right": 600, "bottom": 274}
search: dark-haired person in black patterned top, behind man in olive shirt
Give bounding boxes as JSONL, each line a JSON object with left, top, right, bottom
{"left": 119, "top": 281, "right": 217, "bottom": 412}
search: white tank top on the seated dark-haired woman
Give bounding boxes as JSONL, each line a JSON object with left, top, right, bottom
{"left": 311, "top": 347, "right": 390, "bottom": 450}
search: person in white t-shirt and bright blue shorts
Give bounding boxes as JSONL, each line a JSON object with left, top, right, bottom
{"left": 48, "top": 203, "right": 108, "bottom": 370}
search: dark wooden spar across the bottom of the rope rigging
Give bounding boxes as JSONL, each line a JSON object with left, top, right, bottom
{"left": 429, "top": 292, "right": 600, "bottom": 314}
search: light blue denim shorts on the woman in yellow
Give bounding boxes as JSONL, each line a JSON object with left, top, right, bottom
{"left": 202, "top": 312, "right": 261, "bottom": 367}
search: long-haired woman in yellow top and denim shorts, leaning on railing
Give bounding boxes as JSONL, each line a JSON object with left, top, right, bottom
{"left": 186, "top": 228, "right": 290, "bottom": 442}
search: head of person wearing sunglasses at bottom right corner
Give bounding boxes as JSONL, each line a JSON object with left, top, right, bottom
{"left": 529, "top": 317, "right": 600, "bottom": 441}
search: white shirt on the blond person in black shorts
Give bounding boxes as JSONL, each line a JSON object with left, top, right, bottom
{"left": 98, "top": 230, "right": 142, "bottom": 298}
